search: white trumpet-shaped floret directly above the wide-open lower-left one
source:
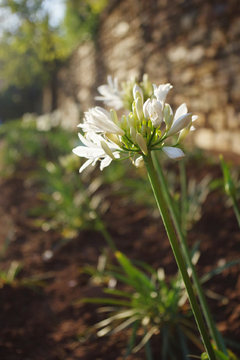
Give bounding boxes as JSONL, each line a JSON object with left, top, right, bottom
{"left": 78, "top": 107, "right": 125, "bottom": 135}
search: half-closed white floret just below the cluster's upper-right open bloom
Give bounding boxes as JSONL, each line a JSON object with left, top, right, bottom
{"left": 143, "top": 99, "right": 163, "bottom": 128}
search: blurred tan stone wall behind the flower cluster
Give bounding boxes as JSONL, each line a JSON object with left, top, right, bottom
{"left": 58, "top": 0, "right": 240, "bottom": 154}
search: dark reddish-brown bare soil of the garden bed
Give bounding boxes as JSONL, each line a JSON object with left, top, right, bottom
{"left": 0, "top": 156, "right": 240, "bottom": 360}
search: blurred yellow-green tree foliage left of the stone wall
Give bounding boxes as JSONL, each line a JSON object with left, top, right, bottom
{"left": 0, "top": 0, "right": 108, "bottom": 119}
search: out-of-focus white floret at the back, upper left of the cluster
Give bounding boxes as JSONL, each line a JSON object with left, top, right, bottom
{"left": 95, "top": 75, "right": 124, "bottom": 110}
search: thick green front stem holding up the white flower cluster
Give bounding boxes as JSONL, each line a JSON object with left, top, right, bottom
{"left": 143, "top": 153, "right": 216, "bottom": 360}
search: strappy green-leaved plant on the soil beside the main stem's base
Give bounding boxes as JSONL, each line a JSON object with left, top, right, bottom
{"left": 80, "top": 252, "right": 202, "bottom": 359}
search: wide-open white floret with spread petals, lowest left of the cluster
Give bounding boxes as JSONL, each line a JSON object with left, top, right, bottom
{"left": 73, "top": 131, "right": 120, "bottom": 172}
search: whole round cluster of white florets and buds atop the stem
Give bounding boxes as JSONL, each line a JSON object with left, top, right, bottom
{"left": 73, "top": 75, "right": 197, "bottom": 172}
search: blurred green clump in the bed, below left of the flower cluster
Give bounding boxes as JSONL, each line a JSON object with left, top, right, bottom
{"left": 31, "top": 155, "right": 108, "bottom": 239}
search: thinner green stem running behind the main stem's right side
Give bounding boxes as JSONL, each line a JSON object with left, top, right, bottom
{"left": 153, "top": 154, "right": 227, "bottom": 354}
